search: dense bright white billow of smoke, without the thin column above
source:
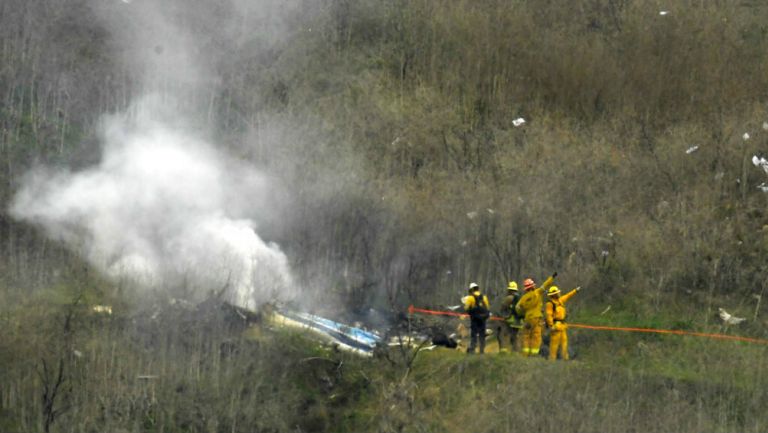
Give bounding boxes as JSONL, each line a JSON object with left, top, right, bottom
{"left": 10, "top": 98, "right": 293, "bottom": 309}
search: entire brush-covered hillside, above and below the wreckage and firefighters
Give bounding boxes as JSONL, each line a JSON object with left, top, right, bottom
{"left": 0, "top": 0, "right": 768, "bottom": 433}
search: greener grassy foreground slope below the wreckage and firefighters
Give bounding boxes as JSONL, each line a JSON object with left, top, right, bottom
{"left": 0, "top": 294, "right": 768, "bottom": 432}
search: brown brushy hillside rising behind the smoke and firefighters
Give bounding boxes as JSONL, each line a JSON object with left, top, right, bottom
{"left": 6, "top": 0, "right": 768, "bottom": 309}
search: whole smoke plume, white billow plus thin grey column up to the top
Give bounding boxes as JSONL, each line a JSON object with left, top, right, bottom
{"left": 10, "top": 1, "right": 304, "bottom": 308}
